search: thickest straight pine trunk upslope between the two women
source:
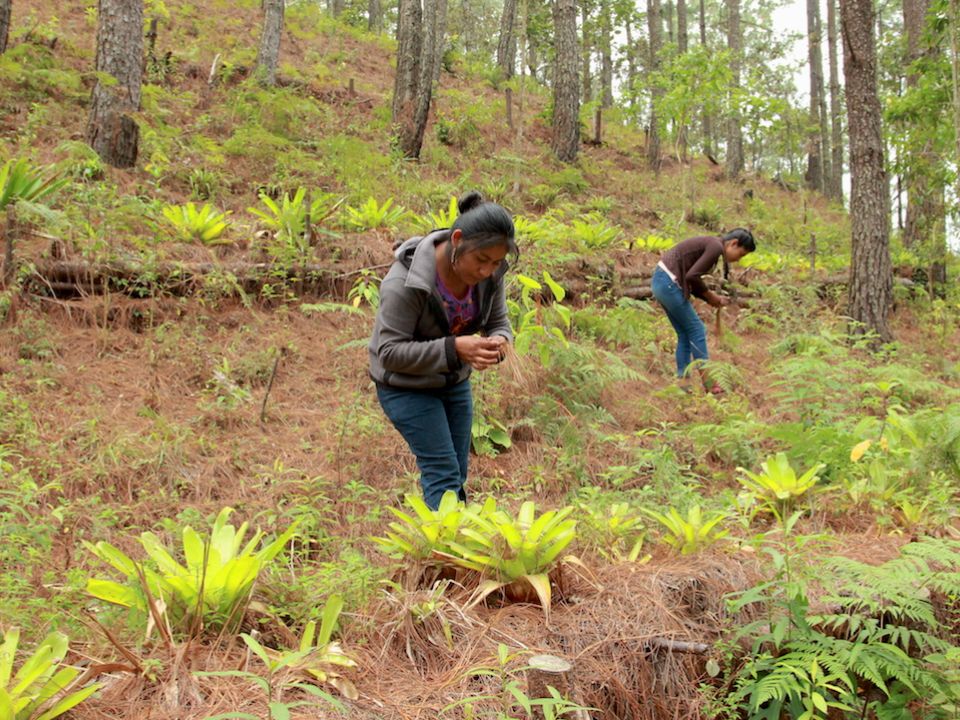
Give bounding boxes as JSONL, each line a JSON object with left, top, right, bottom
{"left": 552, "top": 0, "right": 580, "bottom": 162}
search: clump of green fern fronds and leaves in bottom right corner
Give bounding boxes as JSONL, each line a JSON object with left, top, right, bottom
{"left": 720, "top": 539, "right": 960, "bottom": 720}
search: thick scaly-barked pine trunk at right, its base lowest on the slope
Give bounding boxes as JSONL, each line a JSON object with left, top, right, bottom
{"left": 840, "top": 0, "right": 893, "bottom": 342}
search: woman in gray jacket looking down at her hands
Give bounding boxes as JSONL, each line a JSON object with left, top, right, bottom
{"left": 369, "top": 192, "right": 518, "bottom": 509}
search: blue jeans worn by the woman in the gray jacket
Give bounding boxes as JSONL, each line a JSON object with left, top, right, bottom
{"left": 377, "top": 380, "right": 473, "bottom": 510}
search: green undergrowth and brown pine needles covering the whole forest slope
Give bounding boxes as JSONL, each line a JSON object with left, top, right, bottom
{"left": 0, "top": 0, "right": 960, "bottom": 720}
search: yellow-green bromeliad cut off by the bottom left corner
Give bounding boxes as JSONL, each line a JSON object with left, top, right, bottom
{"left": 0, "top": 628, "right": 100, "bottom": 720}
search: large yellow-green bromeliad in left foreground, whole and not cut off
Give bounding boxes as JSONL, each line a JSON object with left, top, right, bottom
{"left": 84, "top": 508, "right": 297, "bottom": 637}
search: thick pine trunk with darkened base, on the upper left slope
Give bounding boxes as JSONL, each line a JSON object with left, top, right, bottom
{"left": 87, "top": 0, "right": 143, "bottom": 167}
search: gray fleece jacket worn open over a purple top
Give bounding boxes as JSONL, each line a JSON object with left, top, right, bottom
{"left": 369, "top": 230, "right": 513, "bottom": 390}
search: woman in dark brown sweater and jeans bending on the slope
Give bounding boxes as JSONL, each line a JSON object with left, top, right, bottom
{"left": 650, "top": 228, "right": 757, "bottom": 391}
